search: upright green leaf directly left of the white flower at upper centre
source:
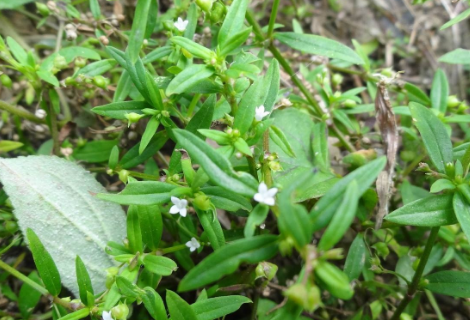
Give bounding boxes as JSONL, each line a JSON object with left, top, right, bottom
{"left": 233, "top": 79, "right": 263, "bottom": 136}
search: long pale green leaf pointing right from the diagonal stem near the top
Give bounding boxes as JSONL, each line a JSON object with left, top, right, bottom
{"left": 274, "top": 32, "right": 364, "bottom": 64}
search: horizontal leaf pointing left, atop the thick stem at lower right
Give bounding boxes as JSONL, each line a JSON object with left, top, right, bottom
{"left": 385, "top": 194, "right": 457, "bottom": 227}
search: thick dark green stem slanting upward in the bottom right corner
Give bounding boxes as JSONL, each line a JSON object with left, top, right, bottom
{"left": 390, "top": 227, "right": 440, "bottom": 320}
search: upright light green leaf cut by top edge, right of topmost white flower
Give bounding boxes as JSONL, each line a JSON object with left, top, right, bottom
{"left": 217, "top": 0, "right": 248, "bottom": 47}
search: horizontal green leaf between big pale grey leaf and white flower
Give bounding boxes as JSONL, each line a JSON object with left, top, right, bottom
{"left": 96, "top": 181, "right": 178, "bottom": 206}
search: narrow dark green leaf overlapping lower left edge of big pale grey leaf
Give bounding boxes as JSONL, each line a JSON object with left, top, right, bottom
{"left": 26, "top": 229, "right": 62, "bottom": 296}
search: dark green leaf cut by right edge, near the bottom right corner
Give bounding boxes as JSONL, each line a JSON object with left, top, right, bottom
{"left": 426, "top": 270, "right": 470, "bottom": 298}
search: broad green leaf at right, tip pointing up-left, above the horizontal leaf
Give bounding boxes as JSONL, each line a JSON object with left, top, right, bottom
{"left": 410, "top": 102, "right": 452, "bottom": 173}
